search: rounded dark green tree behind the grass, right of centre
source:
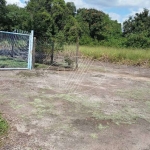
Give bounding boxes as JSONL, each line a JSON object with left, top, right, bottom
{"left": 77, "top": 8, "right": 121, "bottom": 44}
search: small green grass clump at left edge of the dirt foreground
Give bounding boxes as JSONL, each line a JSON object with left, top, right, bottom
{"left": 0, "top": 115, "right": 8, "bottom": 137}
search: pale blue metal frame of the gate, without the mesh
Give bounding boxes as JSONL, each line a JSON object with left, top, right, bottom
{"left": 0, "top": 30, "right": 34, "bottom": 70}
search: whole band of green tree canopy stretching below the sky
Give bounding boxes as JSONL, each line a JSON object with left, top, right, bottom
{"left": 0, "top": 0, "right": 150, "bottom": 48}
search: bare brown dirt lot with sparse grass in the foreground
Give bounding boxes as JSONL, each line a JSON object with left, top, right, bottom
{"left": 0, "top": 61, "right": 150, "bottom": 150}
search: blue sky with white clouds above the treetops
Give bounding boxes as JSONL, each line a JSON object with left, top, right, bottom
{"left": 6, "top": 0, "right": 150, "bottom": 23}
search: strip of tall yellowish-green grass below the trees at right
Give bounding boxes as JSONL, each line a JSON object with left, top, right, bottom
{"left": 80, "top": 46, "right": 150, "bottom": 67}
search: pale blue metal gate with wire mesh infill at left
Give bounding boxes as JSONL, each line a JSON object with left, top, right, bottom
{"left": 0, "top": 31, "right": 33, "bottom": 70}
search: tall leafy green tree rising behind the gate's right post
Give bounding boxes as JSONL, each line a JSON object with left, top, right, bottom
{"left": 27, "top": 0, "right": 67, "bottom": 40}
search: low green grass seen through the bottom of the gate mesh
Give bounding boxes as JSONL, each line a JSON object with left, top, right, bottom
{"left": 0, "top": 56, "right": 27, "bottom": 68}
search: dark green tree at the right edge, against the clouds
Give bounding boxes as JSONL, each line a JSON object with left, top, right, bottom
{"left": 123, "top": 9, "right": 150, "bottom": 48}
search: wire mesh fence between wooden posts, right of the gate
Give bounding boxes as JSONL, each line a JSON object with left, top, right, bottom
{"left": 35, "top": 38, "right": 76, "bottom": 68}
